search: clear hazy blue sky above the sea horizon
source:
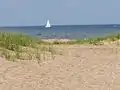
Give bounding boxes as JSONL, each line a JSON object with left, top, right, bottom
{"left": 0, "top": 0, "right": 120, "bottom": 26}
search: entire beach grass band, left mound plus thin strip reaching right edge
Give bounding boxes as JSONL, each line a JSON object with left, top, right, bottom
{"left": 0, "top": 32, "right": 120, "bottom": 63}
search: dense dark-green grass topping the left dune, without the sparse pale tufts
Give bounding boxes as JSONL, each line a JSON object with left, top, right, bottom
{"left": 0, "top": 32, "right": 36, "bottom": 51}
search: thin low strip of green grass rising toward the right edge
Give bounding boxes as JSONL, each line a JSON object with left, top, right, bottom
{"left": 53, "top": 33, "right": 120, "bottom": 45}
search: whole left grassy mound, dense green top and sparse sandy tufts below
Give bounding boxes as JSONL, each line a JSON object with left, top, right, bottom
{"left": 0, "top": 32, "right": 53, "bottom": 62}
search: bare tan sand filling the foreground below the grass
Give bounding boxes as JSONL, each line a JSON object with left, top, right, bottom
{"left": 0, "top": 45, "right": 120, "bottom": 90}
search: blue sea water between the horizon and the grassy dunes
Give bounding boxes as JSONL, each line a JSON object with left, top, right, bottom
{"left": 0, "top": 24, "right": 120, "bottom": 39}
